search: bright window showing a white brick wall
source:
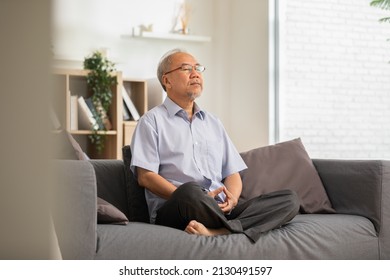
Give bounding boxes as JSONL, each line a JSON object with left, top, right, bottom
{"left": 275, "top": 0, "right": 390, "bottom": 158}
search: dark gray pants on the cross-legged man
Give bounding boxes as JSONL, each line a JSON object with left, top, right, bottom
{"left": 156, "top": 182, "right": 300, "bottom": 242}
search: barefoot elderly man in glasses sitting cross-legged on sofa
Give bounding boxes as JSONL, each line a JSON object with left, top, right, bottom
{"left": 131, "top": 49, "right": 299, "bottom": 242}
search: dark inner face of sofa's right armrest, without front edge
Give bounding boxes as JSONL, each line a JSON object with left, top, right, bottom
{"left": 313, "top": 159, "right": 383, "bottom": 233}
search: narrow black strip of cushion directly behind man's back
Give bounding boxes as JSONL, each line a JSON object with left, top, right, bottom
{"left": 122, "top": 145, "right": 149, "bottom": 223}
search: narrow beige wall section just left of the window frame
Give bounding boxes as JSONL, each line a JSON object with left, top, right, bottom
{"left": 229, "top": 0, "right": 269, "bottom": 150}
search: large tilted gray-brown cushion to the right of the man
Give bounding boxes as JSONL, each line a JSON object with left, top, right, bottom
{"left": 240, "top": 138, "right": 335, "bottom": 213}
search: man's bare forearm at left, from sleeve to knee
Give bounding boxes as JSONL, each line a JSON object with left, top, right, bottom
{"left": 137, "top": 167, "right": 176, "bottom": 199}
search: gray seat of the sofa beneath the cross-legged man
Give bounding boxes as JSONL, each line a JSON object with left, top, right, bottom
{"left": 95, "top": 214, "right": 378, "bottom": 259}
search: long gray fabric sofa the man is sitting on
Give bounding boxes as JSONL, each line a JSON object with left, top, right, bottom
{"left": 53, "top": 155, "right": 390, "bottom": 259}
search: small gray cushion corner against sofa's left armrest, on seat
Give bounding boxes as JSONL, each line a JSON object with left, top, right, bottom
{"left": 97, "top": 197, "right": 129, "bottom": 225}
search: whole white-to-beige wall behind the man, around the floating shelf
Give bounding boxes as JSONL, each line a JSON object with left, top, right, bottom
{"left": 53, "top": 0, "right": 269, "bottom": 151}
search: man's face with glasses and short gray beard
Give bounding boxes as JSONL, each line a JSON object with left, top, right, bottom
{"left": 163, "top": 53, "right": 203, "bottom": 101}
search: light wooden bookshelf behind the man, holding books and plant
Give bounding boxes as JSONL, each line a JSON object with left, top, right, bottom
{"left": 52, "top": 69, "right": 154, "bottom": 159}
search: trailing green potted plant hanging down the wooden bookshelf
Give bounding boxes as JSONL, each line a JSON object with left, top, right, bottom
{"left": 84, "top": 51, "right": 117, "bottom": 154}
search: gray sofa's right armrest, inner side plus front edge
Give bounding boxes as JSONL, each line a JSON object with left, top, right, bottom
{"left": 313, "top": 159, "right": 390, "bottom": 259}
